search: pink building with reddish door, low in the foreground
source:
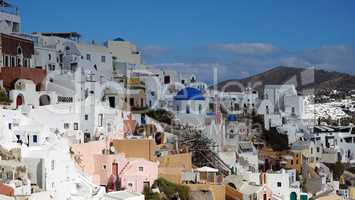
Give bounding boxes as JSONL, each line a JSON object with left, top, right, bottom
{"left": 72, "top": 141, "right": 158, "bottom": 192}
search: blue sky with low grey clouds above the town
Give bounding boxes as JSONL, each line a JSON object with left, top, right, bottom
{"left": 10, "top": 0, "right": 355, "bottom": 82}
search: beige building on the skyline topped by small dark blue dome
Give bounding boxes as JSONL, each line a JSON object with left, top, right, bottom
{"left": 106, "top": 38, "right": 143, "bottom": 64}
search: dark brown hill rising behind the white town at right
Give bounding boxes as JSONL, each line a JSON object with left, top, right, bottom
{"left": 217, "top": 66, "right": 355, "bottom": 93}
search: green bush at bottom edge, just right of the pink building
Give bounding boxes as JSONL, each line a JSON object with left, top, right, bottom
{"left": 156, "top": 178, "right": 190, "bottom": 200}
